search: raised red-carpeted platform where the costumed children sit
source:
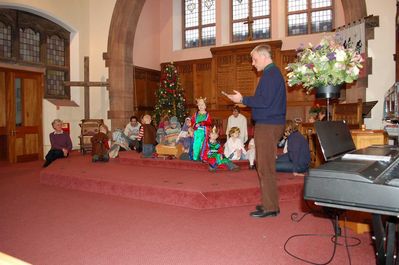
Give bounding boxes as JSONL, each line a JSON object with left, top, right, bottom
{"left": 40, "top": 152, "right": 303, "bottom": 209}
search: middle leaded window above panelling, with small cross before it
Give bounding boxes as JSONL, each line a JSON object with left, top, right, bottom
{"left": 231, "top": 0, "right": 270, "bottom": 42}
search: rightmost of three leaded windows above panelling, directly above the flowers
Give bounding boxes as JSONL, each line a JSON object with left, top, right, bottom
{"left": 287, "top": 0, "right": 334, "bottom": 36}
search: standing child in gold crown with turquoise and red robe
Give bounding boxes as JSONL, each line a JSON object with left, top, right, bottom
{"left": 191, "top": 98, "right": 212, "bottom": 161}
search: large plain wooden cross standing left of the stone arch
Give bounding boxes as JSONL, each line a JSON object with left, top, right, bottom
{"left": 64, "top": 56, "right": 109, "bottom": 119}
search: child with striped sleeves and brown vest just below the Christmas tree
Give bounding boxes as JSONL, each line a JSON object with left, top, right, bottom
{"left": 137, "top": 114, "right": 157, "bottom": 158}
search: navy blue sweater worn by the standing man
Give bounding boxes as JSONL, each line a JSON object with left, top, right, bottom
{"left": 242, "top": 63, "right": 287, "bottom": 124}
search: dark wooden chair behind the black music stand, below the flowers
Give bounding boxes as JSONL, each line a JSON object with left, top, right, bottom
{"left": 332, "top": 99, "right": 363, "bottom": 129}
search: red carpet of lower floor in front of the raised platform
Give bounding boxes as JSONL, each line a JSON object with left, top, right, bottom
{"left": 0, "top": 156, "right": 375, "bottom": 265}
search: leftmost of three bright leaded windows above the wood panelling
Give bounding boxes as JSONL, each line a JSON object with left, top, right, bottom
{"left": 183, "top": 0, "right": 216, "bottom": 48}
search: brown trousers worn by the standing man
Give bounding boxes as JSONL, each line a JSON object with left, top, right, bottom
{"left": 254, "top": 124, "right": 285, "bottom": 211}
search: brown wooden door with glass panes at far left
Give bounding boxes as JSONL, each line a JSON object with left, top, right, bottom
{"left": 0, "top": 68, "right": 43, "bottom": 163}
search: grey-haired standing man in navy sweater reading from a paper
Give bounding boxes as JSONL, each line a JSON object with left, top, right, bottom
{"left": 226, "top": 45, "right": 287, "bottom": 218}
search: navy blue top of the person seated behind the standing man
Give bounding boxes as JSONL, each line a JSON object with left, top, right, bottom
{"left": 287, "top": 131, "right": 310, "bottom": 172}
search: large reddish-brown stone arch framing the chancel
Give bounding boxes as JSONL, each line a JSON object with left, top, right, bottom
{"left": 104, "top": 0, "right": 367, "bottom": 128}
